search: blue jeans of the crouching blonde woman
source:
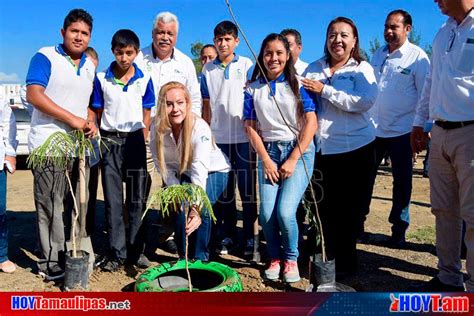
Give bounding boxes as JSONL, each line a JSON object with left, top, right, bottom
{"left": 175, "top": 172, "right": 229, "bottom": 261}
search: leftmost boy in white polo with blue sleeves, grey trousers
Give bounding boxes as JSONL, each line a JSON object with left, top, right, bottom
{"left": 26, "top": 9, "right": 97, "bottom": 280}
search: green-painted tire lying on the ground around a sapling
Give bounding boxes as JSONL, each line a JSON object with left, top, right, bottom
{"left": 135, "top": 260, "right": 242, "bottom": 292}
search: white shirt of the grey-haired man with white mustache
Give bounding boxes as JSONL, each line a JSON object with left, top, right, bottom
{"left": 135, "top": 44, "right": 202, "bottom": 117}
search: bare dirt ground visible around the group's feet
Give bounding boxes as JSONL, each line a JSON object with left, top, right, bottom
{"left": 0, "top": 152, "right": 456, "bottom": 292}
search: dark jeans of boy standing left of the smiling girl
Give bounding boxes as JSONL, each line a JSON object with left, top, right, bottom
{"left": 216, "top": 143, "right": 257, "bottom": 240}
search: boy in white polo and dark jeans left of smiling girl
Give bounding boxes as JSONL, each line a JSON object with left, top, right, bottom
{"left": 201, "top": 21, "right": 257, "bottom": 255}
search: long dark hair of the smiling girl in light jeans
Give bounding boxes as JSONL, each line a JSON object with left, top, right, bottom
{"left": 250, "top": 33, "right": 304, "bottom": 121}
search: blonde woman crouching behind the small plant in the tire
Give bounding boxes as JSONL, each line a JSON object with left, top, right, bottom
{"left": 150, "top": 82, "right": 230, "bottom": 261}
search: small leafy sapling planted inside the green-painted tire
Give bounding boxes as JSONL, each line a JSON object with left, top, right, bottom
{"left": 142, "top": 183, "right": 216, "bottom": 292}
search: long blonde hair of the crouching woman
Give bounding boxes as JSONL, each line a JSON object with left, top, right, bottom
{"left": 154, "top": 81, "right": 196, "bottom": 183}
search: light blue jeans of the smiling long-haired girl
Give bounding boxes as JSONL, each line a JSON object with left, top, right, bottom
{"left": 258, "top": 141, "right": 315, "bottom": 261}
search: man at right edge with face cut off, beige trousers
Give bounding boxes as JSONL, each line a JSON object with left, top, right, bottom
{"left": 412, "top": 0, "right": 474, "bottom": 292}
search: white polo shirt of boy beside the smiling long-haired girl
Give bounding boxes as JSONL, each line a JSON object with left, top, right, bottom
{"left": 201, "top": 55, "right": 252, "bottom": 144}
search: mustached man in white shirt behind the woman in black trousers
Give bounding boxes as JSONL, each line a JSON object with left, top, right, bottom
{"left": 366, "top": 10, "right": 430, "bottom": 247}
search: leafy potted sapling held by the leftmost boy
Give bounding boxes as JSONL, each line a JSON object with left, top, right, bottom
{"left": 27, "top": 130, "right": 95, "bottom": 258}
